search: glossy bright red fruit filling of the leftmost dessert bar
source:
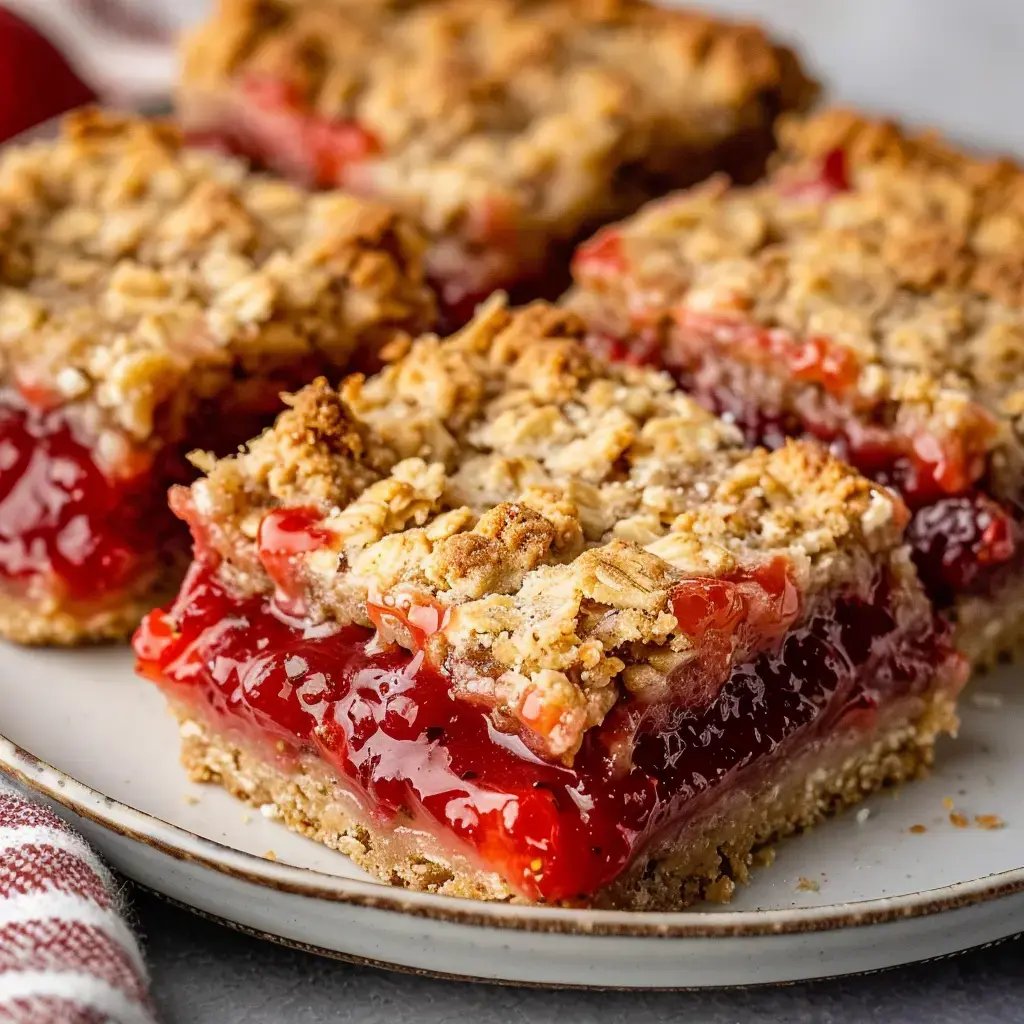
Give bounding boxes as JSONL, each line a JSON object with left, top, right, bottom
{"left": 0, "top": 392, "right": 177, "bottom": 607}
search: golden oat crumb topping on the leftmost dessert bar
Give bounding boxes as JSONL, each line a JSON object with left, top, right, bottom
{"left": 0, "top": 111, "right": 434, "bottom": 442}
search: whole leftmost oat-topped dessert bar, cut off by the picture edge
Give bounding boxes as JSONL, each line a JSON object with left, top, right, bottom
{"left": 0, "top": 111, "right": 435, "bottom": 644}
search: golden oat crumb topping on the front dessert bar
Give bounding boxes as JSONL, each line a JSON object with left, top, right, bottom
{"left": 180, "top": 300, "right": 906, "bottom": 757}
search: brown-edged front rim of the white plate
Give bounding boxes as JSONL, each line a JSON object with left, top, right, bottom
{"left": 0, "top": 734, "right": 1024, "bottom": 939}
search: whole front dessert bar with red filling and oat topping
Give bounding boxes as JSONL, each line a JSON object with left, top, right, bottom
{"left": 135, "top": 299, "right": 964, "bottom": 908}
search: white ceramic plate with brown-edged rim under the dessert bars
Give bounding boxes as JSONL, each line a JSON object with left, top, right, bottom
{"left": 0, "top": 645, "right": 1024, "bottom": 987}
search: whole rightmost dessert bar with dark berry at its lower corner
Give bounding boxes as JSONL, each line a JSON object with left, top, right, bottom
{"left": 570, "top": 111, "right": 1024, "bottom": 665}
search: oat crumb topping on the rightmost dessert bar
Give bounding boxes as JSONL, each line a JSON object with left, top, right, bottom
{"left": 573, "top": 110, "right": 1024, "bottom": 485}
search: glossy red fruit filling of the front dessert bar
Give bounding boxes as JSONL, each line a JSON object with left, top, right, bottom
{"left": 135, "top": 561, "right": 951, "bottom": 901}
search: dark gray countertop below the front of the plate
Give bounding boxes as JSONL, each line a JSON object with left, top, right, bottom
{"left": 134, "top": 893, "right": 1024, "bottom": 1024}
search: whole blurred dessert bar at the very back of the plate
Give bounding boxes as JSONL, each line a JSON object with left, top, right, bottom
{"left": 177, "top": 0, "right": 814, "bottom": 324}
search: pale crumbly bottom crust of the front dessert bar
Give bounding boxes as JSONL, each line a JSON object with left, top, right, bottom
{"left": 174, "top": 690, "right": 956, "bottom": 910}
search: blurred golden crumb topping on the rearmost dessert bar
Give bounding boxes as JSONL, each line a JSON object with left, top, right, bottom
{"left": 179, "top": 0, "right": 814, "bottom": 241}
